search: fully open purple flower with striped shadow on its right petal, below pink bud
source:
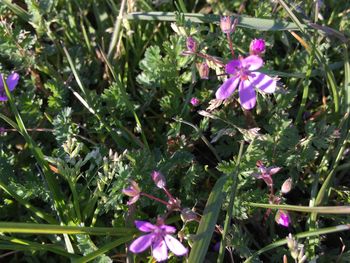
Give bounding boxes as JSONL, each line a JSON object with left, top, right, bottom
{"left": 215, "top": 55, "right": 276, "bottom": 110}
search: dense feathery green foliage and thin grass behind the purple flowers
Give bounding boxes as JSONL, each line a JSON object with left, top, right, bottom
{"left": 0, "top": 0, "right": 350, "bottom": 262}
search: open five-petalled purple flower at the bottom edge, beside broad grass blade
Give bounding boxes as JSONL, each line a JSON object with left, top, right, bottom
{"left": 129, "top": 220, "right": 187, "bottom": 262}
